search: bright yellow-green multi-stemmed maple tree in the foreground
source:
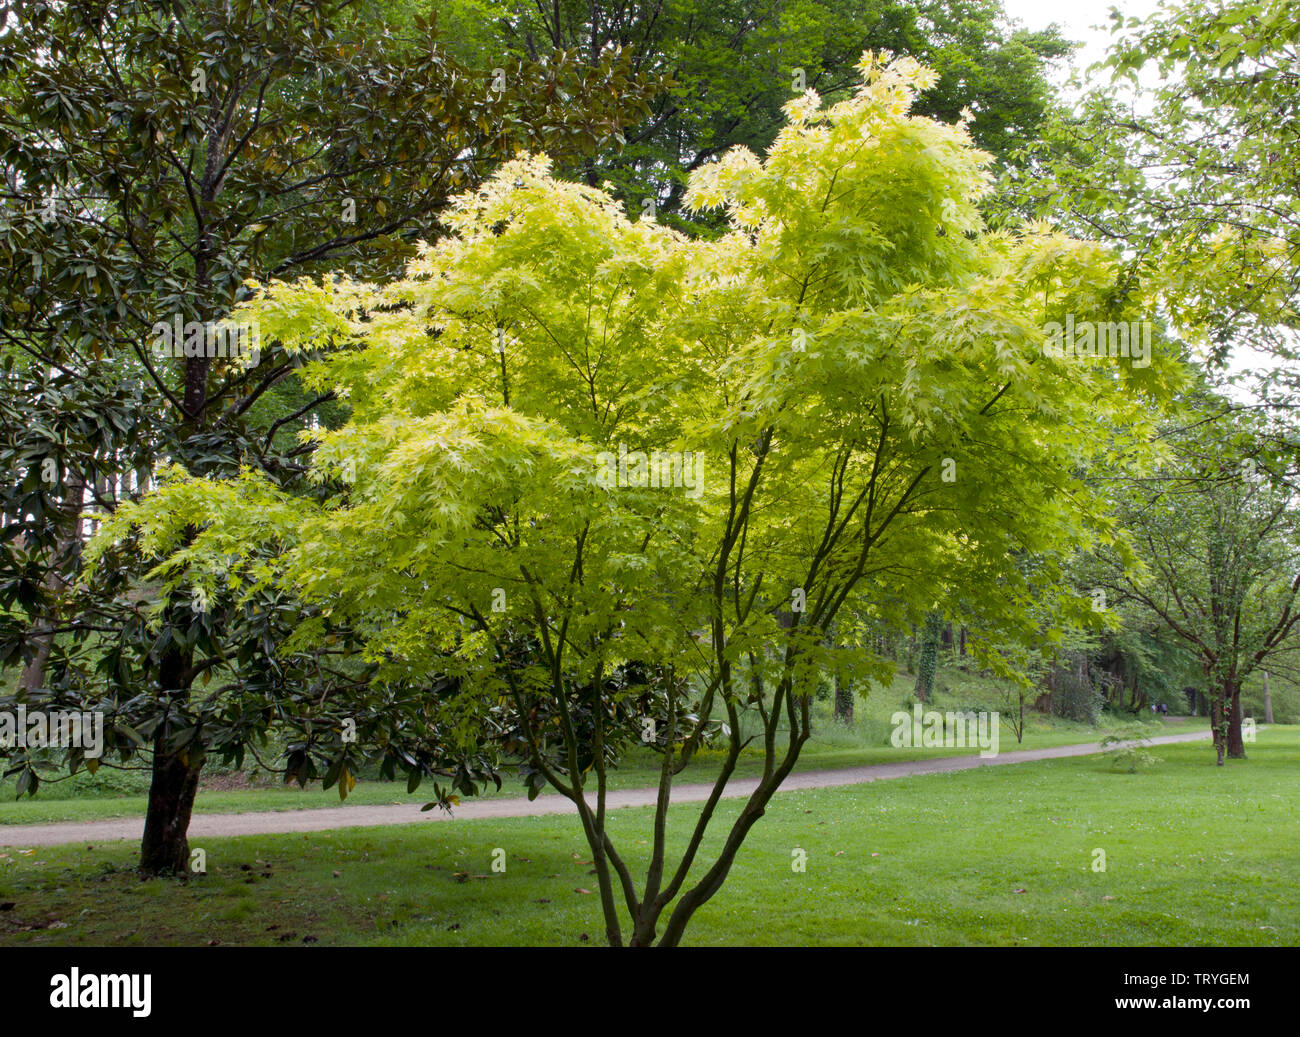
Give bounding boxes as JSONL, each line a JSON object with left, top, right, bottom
{"left": 94, "top": 55, "right": 1174, "bottom": 945}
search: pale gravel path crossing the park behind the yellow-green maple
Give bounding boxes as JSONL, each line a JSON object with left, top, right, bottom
{"left": 0, "top": 729, "right": 1210, "bottom": 847}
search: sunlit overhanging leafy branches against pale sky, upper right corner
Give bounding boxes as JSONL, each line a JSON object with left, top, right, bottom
{"left": 1021, "top": 0, "right": 1300, "bottom": 411}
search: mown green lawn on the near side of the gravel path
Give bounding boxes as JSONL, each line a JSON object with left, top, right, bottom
{"left": 0, "top": 726, "right": 1300, "bottom": 946}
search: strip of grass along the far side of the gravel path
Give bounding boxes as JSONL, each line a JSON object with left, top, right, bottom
{"left": 0, "top": 669, "right": 1138, "bottom": 825}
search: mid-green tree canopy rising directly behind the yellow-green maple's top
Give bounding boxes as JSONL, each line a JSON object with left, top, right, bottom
{"left": 446, "top": 0, "right": 1070, "bottom": 227}
